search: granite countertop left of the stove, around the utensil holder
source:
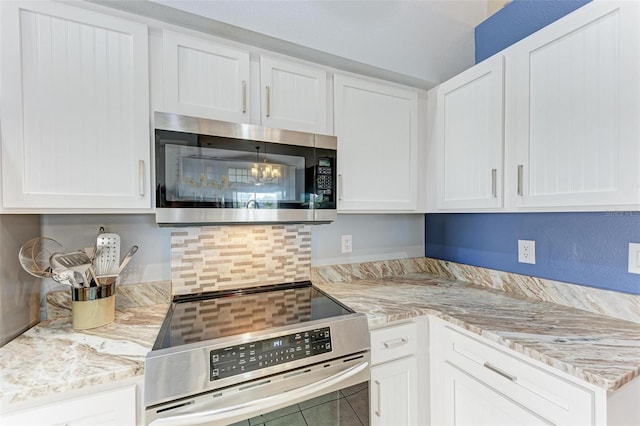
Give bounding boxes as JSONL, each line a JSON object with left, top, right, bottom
{"left": 0, "top": 282, "right": 170, "bottom": 411}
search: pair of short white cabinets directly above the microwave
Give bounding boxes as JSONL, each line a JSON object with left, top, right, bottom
{"left": 162, "top": 30, "right": 331, "bottom": 134}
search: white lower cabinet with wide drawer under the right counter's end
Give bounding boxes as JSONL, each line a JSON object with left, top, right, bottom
{"left": 430, "top": 319, "right": 606, "bottom": 425}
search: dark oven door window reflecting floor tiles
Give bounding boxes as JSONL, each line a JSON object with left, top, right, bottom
{"left": 233, "top": 383, "right": 369, "bottom": 426}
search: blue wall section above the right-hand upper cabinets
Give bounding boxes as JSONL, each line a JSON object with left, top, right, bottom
{"left": 475, "top": 0, "right": 591, "bottom": 63}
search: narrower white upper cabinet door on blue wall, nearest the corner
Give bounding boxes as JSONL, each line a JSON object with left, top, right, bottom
{"left": 436, "top": 55, "right": 504, "bottom": 209}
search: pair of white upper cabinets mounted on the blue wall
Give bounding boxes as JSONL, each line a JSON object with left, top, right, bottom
{"left": 429, "top": 0, "right": 640, "bottom": 211}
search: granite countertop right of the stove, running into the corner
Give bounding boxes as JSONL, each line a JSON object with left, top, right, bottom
{"left": 315, "top": 273, "right": 640, "bottom": 391}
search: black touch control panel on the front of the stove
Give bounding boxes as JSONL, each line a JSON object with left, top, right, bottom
{"left": 209, "top": 327, "right": 333, "bottom": 380}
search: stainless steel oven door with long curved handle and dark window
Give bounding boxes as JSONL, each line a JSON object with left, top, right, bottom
{"left": 146, "top": 352, "right": 370, "bottom": 425}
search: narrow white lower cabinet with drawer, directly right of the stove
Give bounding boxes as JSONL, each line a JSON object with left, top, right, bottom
{"left": 369, "top": 323, "right": 418, "bottom": 426}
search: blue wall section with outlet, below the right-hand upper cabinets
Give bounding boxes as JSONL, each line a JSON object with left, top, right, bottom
{"left": 425, "top": 212, "right": 640, "bottom": 294}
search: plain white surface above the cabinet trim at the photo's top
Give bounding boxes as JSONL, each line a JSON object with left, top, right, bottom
{"left": 152, "top": 0, "right": 487, "bottom": 83}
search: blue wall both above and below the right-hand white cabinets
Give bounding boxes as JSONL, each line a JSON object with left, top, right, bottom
{"left": 425, "top": 0, "right": 640, "bottom": 294}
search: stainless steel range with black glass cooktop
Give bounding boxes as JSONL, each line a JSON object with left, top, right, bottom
{"left": 144, "top": 282, "right": 370, "bottom": 425}
